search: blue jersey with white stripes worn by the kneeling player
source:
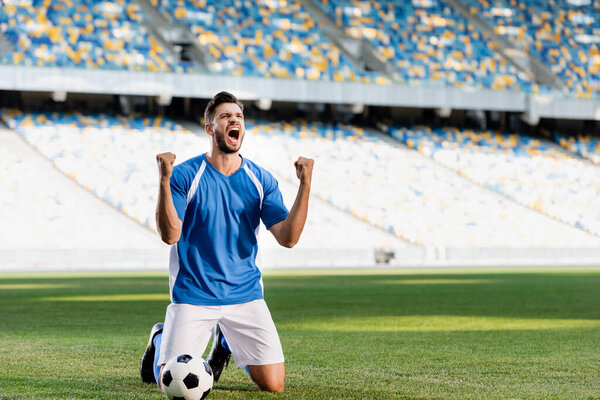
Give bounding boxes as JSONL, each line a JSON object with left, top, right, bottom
{"left": 169, "top": 154, "right": 288, "bottom": 305}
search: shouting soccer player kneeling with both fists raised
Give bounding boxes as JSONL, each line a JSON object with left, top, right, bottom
{"left": 140, "top": 92, "right": 314, "bottom": 392}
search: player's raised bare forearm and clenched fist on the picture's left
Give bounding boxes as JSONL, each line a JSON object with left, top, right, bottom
{"left": 156, "top": 153, "right": 183, "bottom": 244}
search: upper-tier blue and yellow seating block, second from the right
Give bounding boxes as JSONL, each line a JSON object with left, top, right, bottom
{"left": 318, "top": 0, "right": 532, "bottom": 91}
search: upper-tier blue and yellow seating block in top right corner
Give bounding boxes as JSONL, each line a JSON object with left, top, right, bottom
{"left": 462, "top": 0, "right": 600, "bottom": 98}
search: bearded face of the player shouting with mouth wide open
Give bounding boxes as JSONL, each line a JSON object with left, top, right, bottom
{"left": 207, "top": 103, "right": 246, "bottom": 154}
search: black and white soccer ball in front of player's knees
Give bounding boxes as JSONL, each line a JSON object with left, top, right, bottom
{"left": 160, "top": 354, "right": 213, "bottom": 400}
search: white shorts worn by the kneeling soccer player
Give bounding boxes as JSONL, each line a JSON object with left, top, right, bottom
{"left": 158, "top": 300, "right": 284, "bottom": 368}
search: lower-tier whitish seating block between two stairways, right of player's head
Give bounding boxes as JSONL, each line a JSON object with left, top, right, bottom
{"left": 244, "top": 121, "right": 598, "bottom": 247}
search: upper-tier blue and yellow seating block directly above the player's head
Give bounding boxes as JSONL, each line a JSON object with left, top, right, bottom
{"left": 151, "top": 0, "right": 388, "bottom": 83}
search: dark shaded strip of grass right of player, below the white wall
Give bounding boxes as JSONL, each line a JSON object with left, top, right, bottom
{"left": 265, "top": 272, "right": 600, "bottom": 321}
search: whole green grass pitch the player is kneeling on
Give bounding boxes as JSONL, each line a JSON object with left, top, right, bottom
{"left": 0, "top": 267, "right": 600, "bottom": 400}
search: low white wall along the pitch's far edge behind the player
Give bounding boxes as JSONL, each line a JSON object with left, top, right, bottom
{"left": 0, "top": 247, "right": 600, "bottom": 272}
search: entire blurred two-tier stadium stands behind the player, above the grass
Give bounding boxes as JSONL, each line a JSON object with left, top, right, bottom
{"left": 0, "top": 0, "right": 600, "bottom": 271}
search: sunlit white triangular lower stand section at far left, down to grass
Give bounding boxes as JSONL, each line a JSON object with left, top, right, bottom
{"left": 0, "top": 123, "right": 168, "bottom": 272}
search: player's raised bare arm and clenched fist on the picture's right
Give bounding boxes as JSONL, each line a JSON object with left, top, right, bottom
{"left": 269, "top": 157, "right": 315, "bottom": 248}
